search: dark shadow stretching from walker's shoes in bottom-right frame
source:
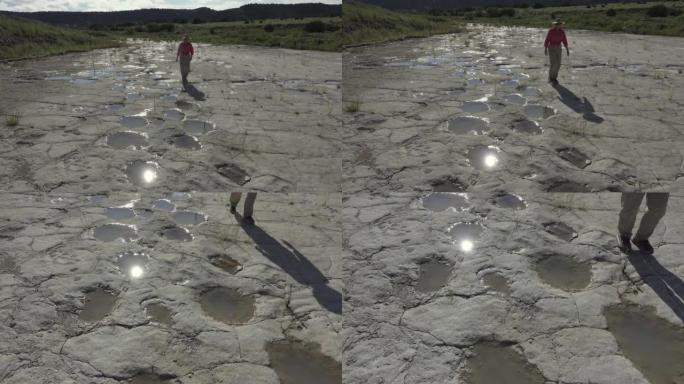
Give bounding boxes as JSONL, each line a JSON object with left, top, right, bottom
{"left": 627, "top": 251, "right": 684, "bottom": 321}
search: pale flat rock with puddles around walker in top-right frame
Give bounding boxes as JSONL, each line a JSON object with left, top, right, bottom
{"left": 343, "top": 26, "right": 684, "bottom": 193}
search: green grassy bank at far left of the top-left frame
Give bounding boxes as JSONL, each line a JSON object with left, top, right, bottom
{"left": 0, "top": 15, "right": 119, "bottom": 60}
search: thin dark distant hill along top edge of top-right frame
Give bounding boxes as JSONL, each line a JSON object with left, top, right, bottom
{"left": 360, "top": 0, "right": 648, "bottom": 10}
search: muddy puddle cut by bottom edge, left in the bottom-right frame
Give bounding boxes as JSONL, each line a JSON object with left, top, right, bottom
{"left": 465, "top": 343, "right": 546, "bottom": 384}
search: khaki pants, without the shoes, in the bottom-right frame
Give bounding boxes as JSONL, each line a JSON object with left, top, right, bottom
{"left": 618, "top": 192, "right": 670, "bottom": 240}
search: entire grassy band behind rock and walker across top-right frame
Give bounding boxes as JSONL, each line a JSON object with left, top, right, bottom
{"left": 343, "top": 0, "right": 684, "bottom": 45}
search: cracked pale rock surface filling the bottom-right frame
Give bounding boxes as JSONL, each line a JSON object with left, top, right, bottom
{"left": 343, "top": 192, "right": 684, "bottom": 384}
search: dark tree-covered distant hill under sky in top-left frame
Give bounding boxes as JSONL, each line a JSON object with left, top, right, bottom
{"left": 0, "top": 3, "right": 342, "bottom": 25}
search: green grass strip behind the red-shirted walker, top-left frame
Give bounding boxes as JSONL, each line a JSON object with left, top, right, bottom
{"left": 109, "top": 17, "right": 342, "bottom": 51}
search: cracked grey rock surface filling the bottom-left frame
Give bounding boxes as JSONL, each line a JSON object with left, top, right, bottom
{"left": 0, "top": 193, "right": 342, "bottom": 384}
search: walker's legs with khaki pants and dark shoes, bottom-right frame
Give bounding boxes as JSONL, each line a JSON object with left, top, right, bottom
{"left": 617, "top": 192, "right": 670, "bottom": 255}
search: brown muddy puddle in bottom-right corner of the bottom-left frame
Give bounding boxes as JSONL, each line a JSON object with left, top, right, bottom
{"left": 266, "top": 341, "right": 342, "bottom": 384}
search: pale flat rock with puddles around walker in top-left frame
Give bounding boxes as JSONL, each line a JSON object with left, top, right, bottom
{"left": 0, "top": 41, "right": 342, "bottom": 194}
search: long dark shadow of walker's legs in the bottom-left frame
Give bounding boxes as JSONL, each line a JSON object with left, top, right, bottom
{"left": 233, "top": 212, "right": 342, "bottom": 314}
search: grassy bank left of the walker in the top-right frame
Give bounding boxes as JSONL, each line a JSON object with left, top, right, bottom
{"left": 342, "top": 0, "right": 463, "bottom": 45}
